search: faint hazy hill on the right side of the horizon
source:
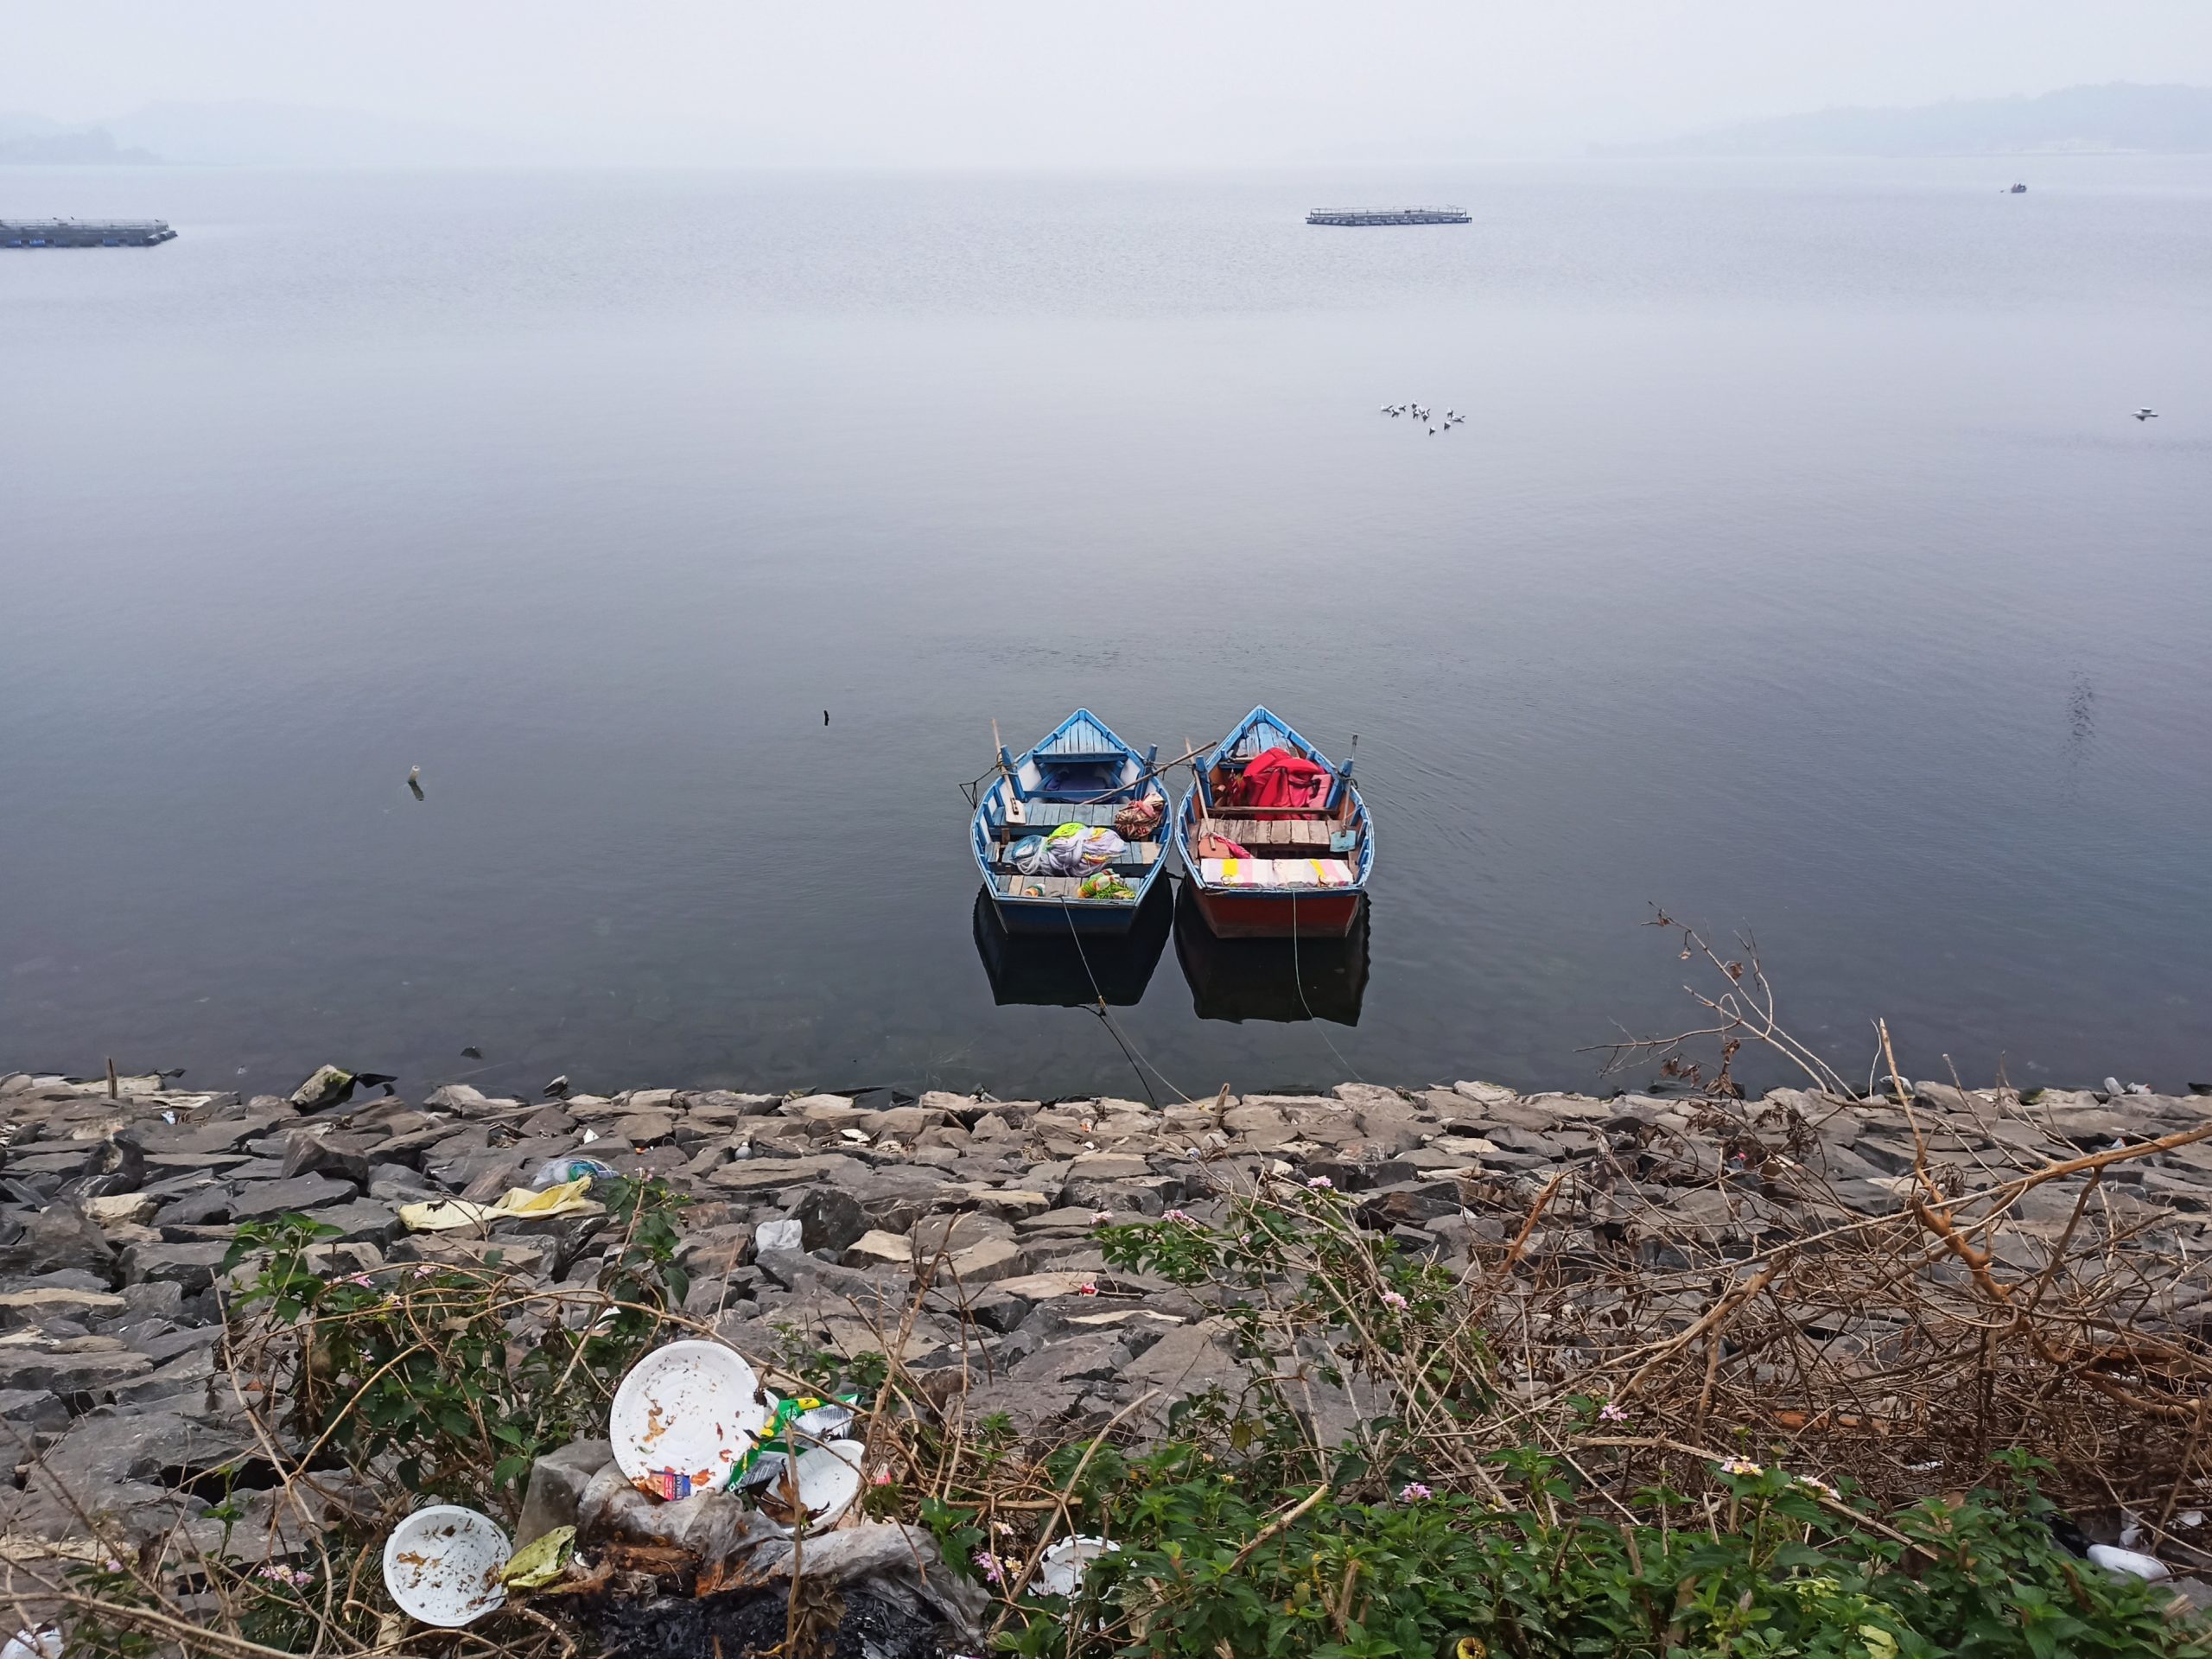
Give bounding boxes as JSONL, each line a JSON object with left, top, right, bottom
{"left": 1604, "top": 82, "right": 2212, "bottom": 155}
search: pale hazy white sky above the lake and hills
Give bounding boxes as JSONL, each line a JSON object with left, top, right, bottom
{"left": 0, "top": 0, "right": 2212, "bottom": 166}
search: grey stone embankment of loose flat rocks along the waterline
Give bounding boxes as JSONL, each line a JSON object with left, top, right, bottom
{"left": 0, "top": 1068, "right": 2212, "bottom": 1555}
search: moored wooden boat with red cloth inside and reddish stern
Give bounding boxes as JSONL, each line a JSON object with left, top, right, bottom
{"left": 1174, "top": 706, "right": 1376, "bottom": 938}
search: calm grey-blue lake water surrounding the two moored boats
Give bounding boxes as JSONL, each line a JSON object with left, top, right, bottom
{"left": 0, "top": 157, "right": 2212, "bottom": 1095}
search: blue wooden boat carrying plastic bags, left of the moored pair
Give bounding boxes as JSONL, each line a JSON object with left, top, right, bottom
{"left": 971, "top": 708, "right": 1168, "bottom": 933}
